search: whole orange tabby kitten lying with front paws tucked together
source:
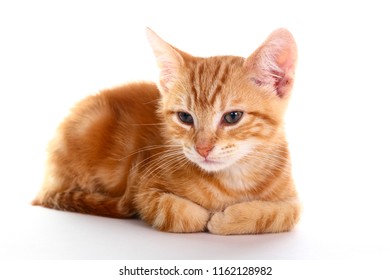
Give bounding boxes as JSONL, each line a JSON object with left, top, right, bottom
{"left": 33, "top": 29, "right": 300, "bottom": 235}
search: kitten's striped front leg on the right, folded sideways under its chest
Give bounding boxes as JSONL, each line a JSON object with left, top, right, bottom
{"left": 207, "top": 200, "right": 300, "bottom": 235}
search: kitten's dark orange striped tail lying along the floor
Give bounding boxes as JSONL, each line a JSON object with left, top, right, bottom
{"left": 32, "top": 190, "right": 135, "bottom": 219}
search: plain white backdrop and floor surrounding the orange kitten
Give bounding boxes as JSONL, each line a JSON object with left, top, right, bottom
{"left": 0, "top": 0, "right": 390, "bottom": 261}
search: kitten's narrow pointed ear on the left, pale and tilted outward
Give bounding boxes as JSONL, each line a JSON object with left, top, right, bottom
{"left": 146, "top": 28, "right": 184, "bottom": 93}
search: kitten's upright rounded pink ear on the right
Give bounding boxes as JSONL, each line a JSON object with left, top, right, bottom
{"left": 245, "top": 28, "right": 297, "bottom": 98}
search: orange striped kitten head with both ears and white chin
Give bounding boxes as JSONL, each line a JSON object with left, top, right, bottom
{"left": 147, "top": 29, "right": 297, "bottom": 172}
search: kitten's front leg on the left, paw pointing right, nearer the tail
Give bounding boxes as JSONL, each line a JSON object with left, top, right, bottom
{"left": 135, "top": 189, "right": 210, "bottom": 233}
